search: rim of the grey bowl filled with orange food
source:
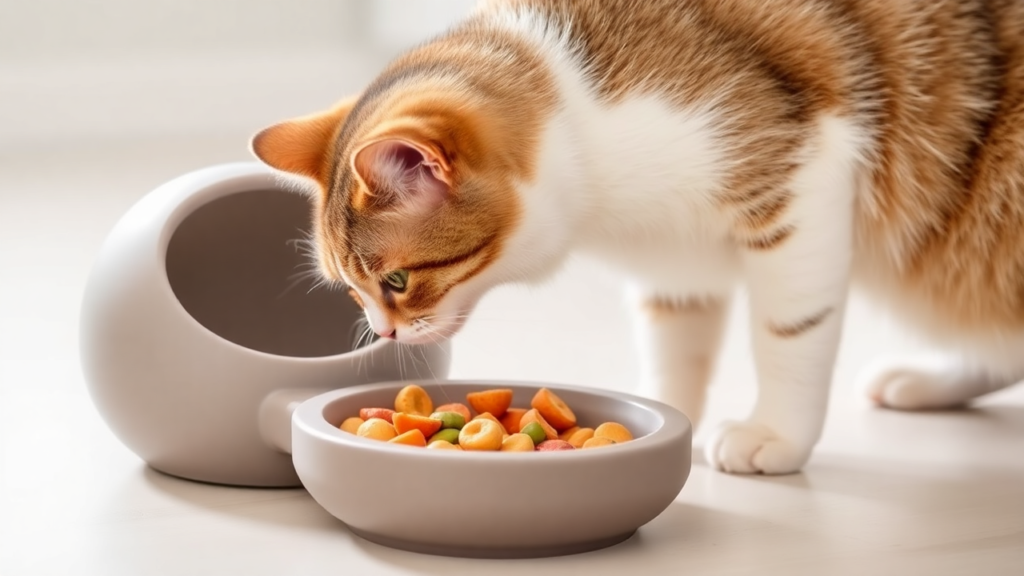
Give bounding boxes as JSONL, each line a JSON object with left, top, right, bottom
{"left": 292, "top": 378, "right": 692, "bottom": 465}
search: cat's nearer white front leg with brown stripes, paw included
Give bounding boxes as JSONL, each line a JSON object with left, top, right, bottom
{"left": 706, "top": 124, "right": 854, "bottom": 474}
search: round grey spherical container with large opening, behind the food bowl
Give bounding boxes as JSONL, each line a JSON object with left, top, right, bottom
{"left": 81, "top": 163, "right": 450, "bottom": 486}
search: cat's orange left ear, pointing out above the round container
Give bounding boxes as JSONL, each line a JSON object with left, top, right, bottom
{"left": 250, "top": 97, "right": 356, "bottom": 188}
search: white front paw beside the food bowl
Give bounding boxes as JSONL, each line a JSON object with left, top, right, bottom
{"left": 705, "top": 422, "right": 811, "bottom": 475}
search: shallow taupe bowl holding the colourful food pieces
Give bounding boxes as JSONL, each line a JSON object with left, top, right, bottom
{"left": 290, "top": 381, "right": 692, "bottom": 558}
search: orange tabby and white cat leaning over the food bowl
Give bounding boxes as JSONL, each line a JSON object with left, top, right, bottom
{"left": 245, "top": 0, "right": 1024, "bottom": 474}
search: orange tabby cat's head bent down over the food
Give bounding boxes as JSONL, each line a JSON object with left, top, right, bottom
{"left": 251, "top": 87, "right": 552, "bottom": 343}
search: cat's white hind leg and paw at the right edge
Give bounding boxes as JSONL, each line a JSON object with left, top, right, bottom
{"left": 862, "top": 357, "right": 1024, "bottom": 410}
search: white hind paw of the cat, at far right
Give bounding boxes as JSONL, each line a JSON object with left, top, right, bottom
{"left": 864, "top": 366, "right": 966, "bottom": 410}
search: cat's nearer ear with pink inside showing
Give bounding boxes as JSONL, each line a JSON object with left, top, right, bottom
{"left": 352, "top": 138, "right": 453, "bottom": 214}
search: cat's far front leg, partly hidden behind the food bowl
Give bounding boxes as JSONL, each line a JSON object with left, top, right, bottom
{"left": 636, "top": 294, "right": 728, "bottom": 428}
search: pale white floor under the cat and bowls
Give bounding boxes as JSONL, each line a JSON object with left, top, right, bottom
{"left": 0, "top": 132, "right": 1024, "bottom": 576}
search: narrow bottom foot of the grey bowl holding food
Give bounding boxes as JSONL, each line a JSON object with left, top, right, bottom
{"left": 348, "top": 526, "right": 636, "bottom": 560}
